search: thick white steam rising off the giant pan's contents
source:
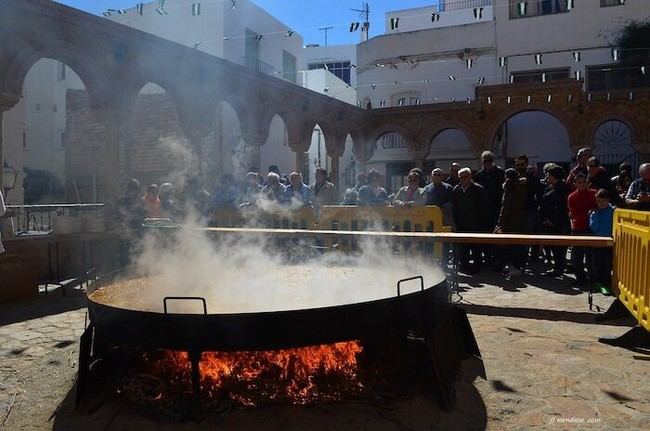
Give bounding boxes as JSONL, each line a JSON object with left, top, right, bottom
{"left": 100, "top": 201, "right": 444, "bottom": 313}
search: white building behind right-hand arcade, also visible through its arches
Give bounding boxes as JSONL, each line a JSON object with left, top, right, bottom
{"left": 357, "top": 0, "right": 650, "bottom": 186}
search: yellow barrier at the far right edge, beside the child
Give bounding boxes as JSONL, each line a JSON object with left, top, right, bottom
{"left": 614, "top": 209, "right": 650, "bottom": 331}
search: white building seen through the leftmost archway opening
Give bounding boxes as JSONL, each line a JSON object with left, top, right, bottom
{"left": 0, "top": 56, "right": 90, "bottom": 204}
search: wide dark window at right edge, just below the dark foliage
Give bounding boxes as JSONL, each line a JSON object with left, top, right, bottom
{"left": 587, "top": 65, "right": 650, "bottom": 92}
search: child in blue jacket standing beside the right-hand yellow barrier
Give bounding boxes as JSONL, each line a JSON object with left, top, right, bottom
{"left": 589, "top": 189, "right": 614, "bottom": 295}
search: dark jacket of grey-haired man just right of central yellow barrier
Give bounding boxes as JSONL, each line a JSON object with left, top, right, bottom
{"left": 453, "top": 183, "right": 488, "bottom": 232}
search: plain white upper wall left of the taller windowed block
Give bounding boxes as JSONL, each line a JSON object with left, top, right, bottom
{"left": 357, "top": 22, "right": 502, "bottom": 108}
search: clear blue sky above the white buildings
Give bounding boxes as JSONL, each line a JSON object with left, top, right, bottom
{"left": 56, "top": 0, "right": 438, "bottom": 45}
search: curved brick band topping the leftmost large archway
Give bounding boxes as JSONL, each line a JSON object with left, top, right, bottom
{"left": 3, "top": 39, "right": 106, "bottom": 106}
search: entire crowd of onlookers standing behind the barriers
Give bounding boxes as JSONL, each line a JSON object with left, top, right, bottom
{"left": 117, "top": 148, "right": 650, "bottom": 292}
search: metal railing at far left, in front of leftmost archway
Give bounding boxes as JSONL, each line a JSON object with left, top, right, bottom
{"left": 7, "top": 204, "right": 104, "bottom": 235}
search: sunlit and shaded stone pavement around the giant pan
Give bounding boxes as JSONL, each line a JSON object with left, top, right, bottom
{"left": 0, "top": 273, "right": 650, "bottom": 431}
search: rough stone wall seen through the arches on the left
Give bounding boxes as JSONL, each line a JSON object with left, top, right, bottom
{"left": 66, "top": 90, "right": 216, "bottom": 202}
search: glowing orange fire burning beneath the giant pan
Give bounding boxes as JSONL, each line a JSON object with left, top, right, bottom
{"left": 113, "top": 341, "right": 363, "bottom": 407}
